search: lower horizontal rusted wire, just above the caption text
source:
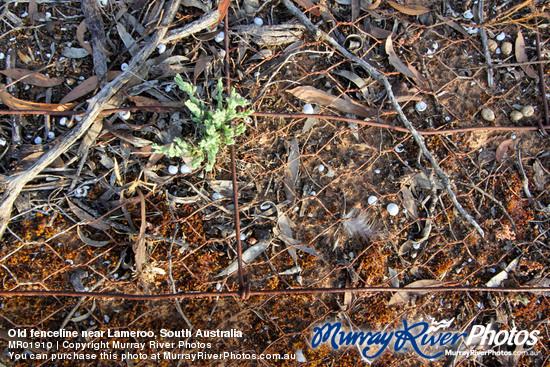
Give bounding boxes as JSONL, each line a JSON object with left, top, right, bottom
{"left": 0, "top": 287, "right": 550, "bottom": 301}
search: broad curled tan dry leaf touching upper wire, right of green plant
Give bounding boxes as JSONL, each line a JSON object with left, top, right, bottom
{"left": 289, "top": 86, "right": 377, "bottom": 117}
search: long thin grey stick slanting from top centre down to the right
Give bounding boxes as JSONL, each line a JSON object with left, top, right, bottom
{"left": 282, "top": 0, "right": 485, "bottom": 237}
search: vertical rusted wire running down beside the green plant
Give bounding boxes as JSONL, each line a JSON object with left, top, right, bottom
{"left": 223, "top": 9, "right": 247, "bottom": 298}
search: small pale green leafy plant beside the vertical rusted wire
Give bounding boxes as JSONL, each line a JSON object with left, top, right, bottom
{"left": 153, "top": 74, "right": 253, "bottom": 171}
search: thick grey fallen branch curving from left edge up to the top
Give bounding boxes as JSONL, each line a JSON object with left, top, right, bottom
{"left": 0, "top": 0, "right": 180, "bottom": 238}
